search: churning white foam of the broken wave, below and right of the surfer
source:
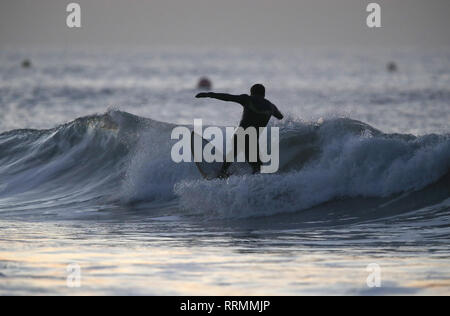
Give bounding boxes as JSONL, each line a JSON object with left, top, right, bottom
{"left": 175, "top": 120, "right": 450, "bottom": 217}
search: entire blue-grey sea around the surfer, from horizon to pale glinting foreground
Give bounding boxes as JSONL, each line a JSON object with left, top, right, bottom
{"left": 0, "top": 49, "right": 450, "bottom": 295}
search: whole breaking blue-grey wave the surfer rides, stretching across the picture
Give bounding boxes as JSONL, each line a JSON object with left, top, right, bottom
{"left": 0, "top": 111, "right": 450, "bottom": 218}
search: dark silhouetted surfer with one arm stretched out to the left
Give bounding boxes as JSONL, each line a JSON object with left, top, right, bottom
{"left": 195, "top": 84, "right": 283, "bottom": 178}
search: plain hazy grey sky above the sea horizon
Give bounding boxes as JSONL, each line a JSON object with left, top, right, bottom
{"left": 0, "top": 0, "right": 450, "bottom": 48}
